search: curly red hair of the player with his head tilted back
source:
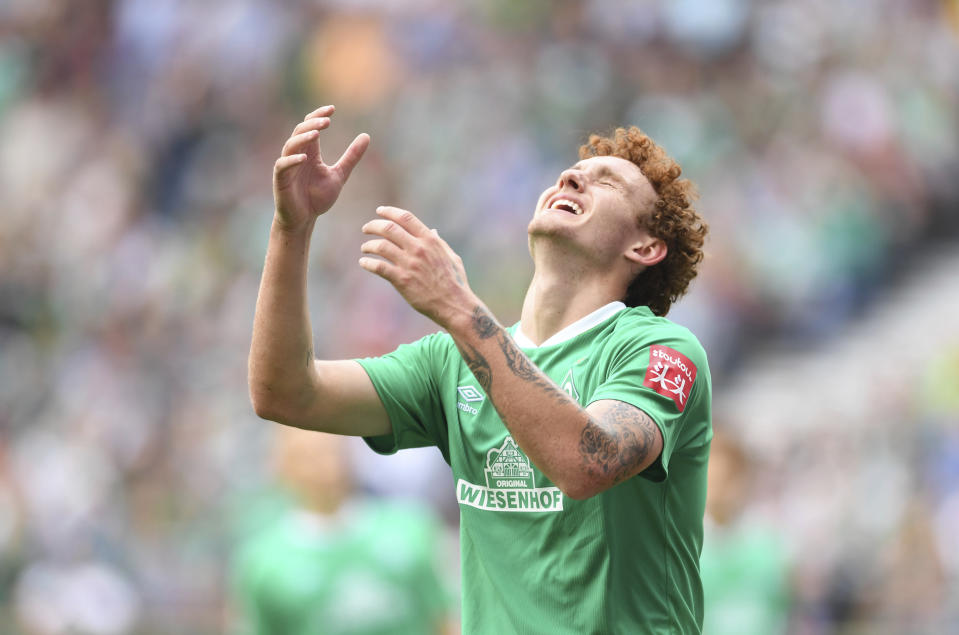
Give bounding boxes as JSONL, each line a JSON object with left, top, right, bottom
{"left": 579, "top": 126, "right": 709, "bottom": 315}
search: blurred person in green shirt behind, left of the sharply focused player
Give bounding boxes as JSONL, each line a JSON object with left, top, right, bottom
{"left": 234, "top": 428, "right": 452, "bottom": 635}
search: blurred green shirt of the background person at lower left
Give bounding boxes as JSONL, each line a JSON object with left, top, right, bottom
{"left": 233, "top": 501, "right": 450, "bottom": 635}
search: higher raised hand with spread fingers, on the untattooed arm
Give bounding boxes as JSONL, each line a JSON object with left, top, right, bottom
{"left": 273, "top": 106, "right": 370, "bottom": 230}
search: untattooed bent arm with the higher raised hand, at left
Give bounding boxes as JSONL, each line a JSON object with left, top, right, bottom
{"left": 249, "top": 106, "right": 391, "bottom": 436}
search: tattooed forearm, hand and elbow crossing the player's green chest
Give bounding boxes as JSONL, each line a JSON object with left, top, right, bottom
{"left": 360, "top": 207, "right": 663, "bottom": 499}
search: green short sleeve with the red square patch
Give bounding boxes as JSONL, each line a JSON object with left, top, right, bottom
{"left": 589, "top": 337, "right": 709, "bottom": 481}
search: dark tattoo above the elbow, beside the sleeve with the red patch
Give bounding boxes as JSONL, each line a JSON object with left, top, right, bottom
{"left": 579, "top": 400, "right": 661, "bottom": 484}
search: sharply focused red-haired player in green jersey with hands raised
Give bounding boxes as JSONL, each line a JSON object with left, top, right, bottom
{"left": 249, "top": 106, "right": 712, "bottom": 634}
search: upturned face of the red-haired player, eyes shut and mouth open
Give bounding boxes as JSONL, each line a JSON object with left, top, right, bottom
{"left": 528, "top": 156, "right": 657, "bottom": 264}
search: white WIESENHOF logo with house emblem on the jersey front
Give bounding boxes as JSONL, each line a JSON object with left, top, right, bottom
{"left": 456, "top": 436, "right": 563, "bottom": 512}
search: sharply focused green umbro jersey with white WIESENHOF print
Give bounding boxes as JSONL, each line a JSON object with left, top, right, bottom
{"left": 359, "top": 303, "right": 712, "bottom": 635}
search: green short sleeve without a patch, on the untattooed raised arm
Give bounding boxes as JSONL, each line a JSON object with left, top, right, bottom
{"left": 356, "top": 333, "right": 449, "bottom": 461}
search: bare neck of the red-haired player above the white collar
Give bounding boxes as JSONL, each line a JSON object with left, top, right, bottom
{"left": 520, "top": 267, "right": 624, "bottom": 345}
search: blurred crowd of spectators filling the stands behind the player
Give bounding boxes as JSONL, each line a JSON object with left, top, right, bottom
{"left": 0, "top": 0, "right": 959, "bottom": 635}
